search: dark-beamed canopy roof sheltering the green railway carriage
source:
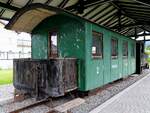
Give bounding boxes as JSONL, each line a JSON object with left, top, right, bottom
{"left": 0, "top": 0, "right": 150, "bottom": 37}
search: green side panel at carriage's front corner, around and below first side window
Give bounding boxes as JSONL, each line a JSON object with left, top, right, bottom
{"left": 85, "top": 23, "right": 104, "bottom": 90}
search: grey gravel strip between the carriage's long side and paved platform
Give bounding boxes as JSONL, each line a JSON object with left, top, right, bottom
{"left": 70, "top": 70, "right": 150, "bottom": 113}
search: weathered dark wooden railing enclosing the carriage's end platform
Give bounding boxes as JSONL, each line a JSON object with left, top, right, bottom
{"left": 13, "top": 58, "right": 77, "bottom": 97}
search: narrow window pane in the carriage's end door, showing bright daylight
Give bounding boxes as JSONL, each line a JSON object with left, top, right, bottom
{"left": 49, "top": 32, "right": 58, "bottom": 57}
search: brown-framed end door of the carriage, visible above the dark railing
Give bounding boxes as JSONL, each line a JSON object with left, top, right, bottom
{"left": 48, "top": 31, "right": 58, "bottom": 58}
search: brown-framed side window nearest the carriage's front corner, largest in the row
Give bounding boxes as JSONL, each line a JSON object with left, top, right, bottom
{"left": 92, "top": 31, "right": 103, "bottom": 58}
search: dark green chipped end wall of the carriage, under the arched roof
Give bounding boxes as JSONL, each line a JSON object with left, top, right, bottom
{"left": 32, "top": 15, "right": 85, "bottom": 90}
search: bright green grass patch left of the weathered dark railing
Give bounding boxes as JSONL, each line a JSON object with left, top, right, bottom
{"left": 0, "top": 69, "right": 13, "bottom": 85}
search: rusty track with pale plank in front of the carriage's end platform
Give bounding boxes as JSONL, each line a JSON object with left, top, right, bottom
{"left": 8, "top": 91, "right": 85, "bottom": 113}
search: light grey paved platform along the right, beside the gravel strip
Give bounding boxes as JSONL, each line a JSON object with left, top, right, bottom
{"left": 90, "top": 74, "right": 150, "bottom": 113}
